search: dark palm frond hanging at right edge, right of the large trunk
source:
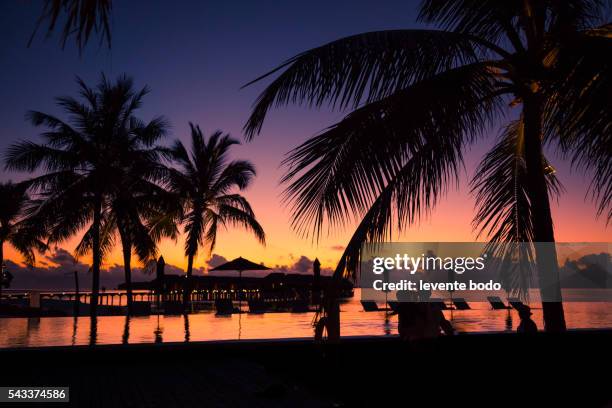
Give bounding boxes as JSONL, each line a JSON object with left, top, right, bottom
{"left": 546, "top": 24, "right": 612, "bottom": 222}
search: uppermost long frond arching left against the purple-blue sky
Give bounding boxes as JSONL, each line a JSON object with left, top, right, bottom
{"left": 244, "top": 30, "right": 492, "bottom": 139}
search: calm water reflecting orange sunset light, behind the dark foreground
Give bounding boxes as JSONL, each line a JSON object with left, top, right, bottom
{"left": 0, "top": 292, "right": 612, "bottom": 347}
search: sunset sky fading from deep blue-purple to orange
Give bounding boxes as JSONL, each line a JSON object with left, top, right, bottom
{"left": 0, "top": 0, "right": 612, "bottom": 288}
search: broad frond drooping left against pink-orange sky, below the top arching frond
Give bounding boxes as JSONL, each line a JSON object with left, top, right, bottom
{"left": 282, "top": 63, "right": 502, "bottom": 238}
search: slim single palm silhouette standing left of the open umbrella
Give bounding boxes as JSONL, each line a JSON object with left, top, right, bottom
{"left": 167, "top": 123, "right": 265, "bottom": 307}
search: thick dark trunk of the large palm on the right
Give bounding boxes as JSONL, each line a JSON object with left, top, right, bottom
{"left": 523, "top": 92, "right": 566, "bottom": 332}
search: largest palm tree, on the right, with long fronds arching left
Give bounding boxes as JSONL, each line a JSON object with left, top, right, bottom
{"left": 245, "top": 0, "right": 612, "bottom": 331}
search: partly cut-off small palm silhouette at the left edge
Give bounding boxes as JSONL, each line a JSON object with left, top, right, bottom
{"left": 0, "top": 181, "right": 47, "bottom": 290}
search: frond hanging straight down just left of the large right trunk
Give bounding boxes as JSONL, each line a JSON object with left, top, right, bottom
{"left": 472, "top": 119, "right": 563, "bottom": 299}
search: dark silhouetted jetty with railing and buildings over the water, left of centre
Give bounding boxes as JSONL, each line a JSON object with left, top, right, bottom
{"left": 0, "top": 272, "right": 353, "bottom": 317}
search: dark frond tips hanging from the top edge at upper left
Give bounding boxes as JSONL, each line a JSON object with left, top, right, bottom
{"left": 28, "top": 0, "right": 113, "bottom": 52}
